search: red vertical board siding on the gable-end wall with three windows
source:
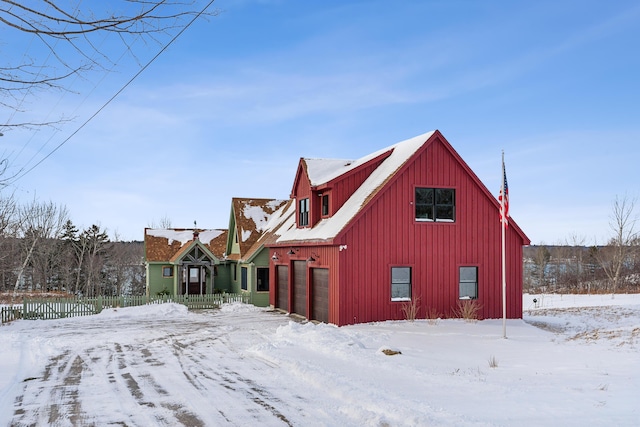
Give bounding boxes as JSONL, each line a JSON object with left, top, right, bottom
{"left": 334, "top": 135, "right": 524, "bottom": 325}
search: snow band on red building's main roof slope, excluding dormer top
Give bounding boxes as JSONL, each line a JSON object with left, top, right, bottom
{"left": 277, "top": 131, "right": 435, "bottom": 242}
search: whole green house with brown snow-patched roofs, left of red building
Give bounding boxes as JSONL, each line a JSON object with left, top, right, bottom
{"left": 144, "top": 198, "right": 295, "bottom": 307}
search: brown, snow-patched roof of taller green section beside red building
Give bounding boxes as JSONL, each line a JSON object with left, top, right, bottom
{"left": 227, "top": 197, "right": 288, "bottom": 259}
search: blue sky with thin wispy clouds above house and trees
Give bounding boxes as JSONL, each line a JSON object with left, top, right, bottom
{"left": 0, "top": 0, "right": 640, "bottom": 244}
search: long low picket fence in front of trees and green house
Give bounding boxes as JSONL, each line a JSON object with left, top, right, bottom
{"left": 0, "top": 294, "right": 249, "bottom": 323}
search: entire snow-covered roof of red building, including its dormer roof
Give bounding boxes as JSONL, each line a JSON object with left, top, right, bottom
{"left": 277, "top": 131, "right": 435, "bottom": 243}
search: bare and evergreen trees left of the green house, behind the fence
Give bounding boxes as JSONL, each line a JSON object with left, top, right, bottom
{"left": 0, "top": 198, "right": 145, "bottom": 297}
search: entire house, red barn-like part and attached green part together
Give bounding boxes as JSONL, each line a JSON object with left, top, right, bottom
{"left": 145, "top": 131, "right": 530, "bottom": 325}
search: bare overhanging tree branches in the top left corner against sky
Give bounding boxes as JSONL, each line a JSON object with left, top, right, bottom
{"left": 0, "top": 0, "right": 217, "bottom": 132}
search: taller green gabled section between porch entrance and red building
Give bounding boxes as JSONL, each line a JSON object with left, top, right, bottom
{"left": 225, "top": 198, "right": 293, "bottom": 307}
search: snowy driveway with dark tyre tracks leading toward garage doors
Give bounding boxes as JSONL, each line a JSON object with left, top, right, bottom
{"left": 3, "top": 305, "right": 320, "bottom": 426}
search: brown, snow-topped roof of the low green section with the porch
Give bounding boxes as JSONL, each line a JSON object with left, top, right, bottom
{"left": 144, "top": 228, "right": 228, "bottom": 262}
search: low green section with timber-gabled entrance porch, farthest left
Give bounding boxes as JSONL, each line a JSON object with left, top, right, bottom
{"left": 144, "top": 228, "right": 231, "bottom": 295}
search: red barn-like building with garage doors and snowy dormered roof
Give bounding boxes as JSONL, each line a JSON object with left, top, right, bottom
{"left": 266, "top": 131, "right": 530, "bottom": 325}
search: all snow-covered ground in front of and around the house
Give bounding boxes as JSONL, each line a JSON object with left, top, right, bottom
{"left": 0, "top": 295, "right": 640, "bottom": 427}
